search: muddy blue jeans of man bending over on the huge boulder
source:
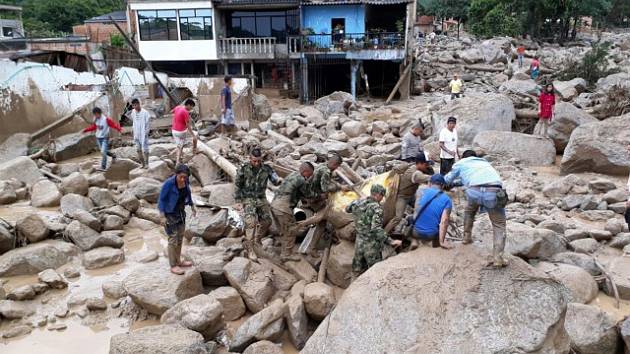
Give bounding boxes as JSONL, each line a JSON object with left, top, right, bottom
{"left": 464, "top": 187, "right": 506, "bottom": 259}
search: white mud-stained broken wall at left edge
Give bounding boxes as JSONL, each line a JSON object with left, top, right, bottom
{"left": 0, "top": 60, "right": 109, "bottom": 142}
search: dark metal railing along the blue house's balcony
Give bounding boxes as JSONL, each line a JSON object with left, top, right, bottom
{"left": 296, "top": 32, "right": 405, "bottom": 53}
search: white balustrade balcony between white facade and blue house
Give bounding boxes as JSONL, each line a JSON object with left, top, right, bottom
{"left": 217, "top": 37, "right": 276, "bottom": 60}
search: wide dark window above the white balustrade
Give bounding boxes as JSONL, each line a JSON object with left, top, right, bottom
{"left": 227, "top": 9, "right": 299, "bottom": 43}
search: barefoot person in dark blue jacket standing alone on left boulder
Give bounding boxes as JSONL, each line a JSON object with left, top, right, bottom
{"left": 158, "top": 165, "right": 197, "bottom": 275}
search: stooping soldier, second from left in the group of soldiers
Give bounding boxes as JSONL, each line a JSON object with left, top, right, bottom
{"left": 271, "top": 162, "right": 314, "bottom": 262}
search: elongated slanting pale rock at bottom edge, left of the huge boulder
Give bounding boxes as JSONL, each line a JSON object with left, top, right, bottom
{"left": 229, "top": 299, "right": 286, "bottom": 352}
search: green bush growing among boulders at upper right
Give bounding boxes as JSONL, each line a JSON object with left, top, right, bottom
{"left": 560, "top": 42, "right": 617, "bottom": 85}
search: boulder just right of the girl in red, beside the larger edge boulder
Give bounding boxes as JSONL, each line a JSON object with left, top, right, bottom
{"left": 548, "top": 102, "right": 598, "bottom": 152}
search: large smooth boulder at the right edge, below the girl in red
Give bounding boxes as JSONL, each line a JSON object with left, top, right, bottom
{"left": 560, "top": 114, "right": 630, "bottom": 174}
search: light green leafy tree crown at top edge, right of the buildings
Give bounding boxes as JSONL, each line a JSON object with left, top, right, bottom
{"left": 468, "top": 0, "right": 523, "bottom": 37}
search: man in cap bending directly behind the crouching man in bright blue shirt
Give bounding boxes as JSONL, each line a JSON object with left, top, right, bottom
{"left": 385, "top": 152, "right": 433, "bottom": 235}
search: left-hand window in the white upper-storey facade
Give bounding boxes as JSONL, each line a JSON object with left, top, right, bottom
{"left": 138, "top": 10, "right": 179, "bottom": 41}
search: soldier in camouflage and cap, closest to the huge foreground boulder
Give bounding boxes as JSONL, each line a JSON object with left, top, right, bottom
{"left": 346, "top": 184, "right": 402, "bottom": 278}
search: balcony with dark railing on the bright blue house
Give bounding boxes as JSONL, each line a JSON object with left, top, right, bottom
{"left": 296, "top": 32, "right": 405, "bottom": 60}
